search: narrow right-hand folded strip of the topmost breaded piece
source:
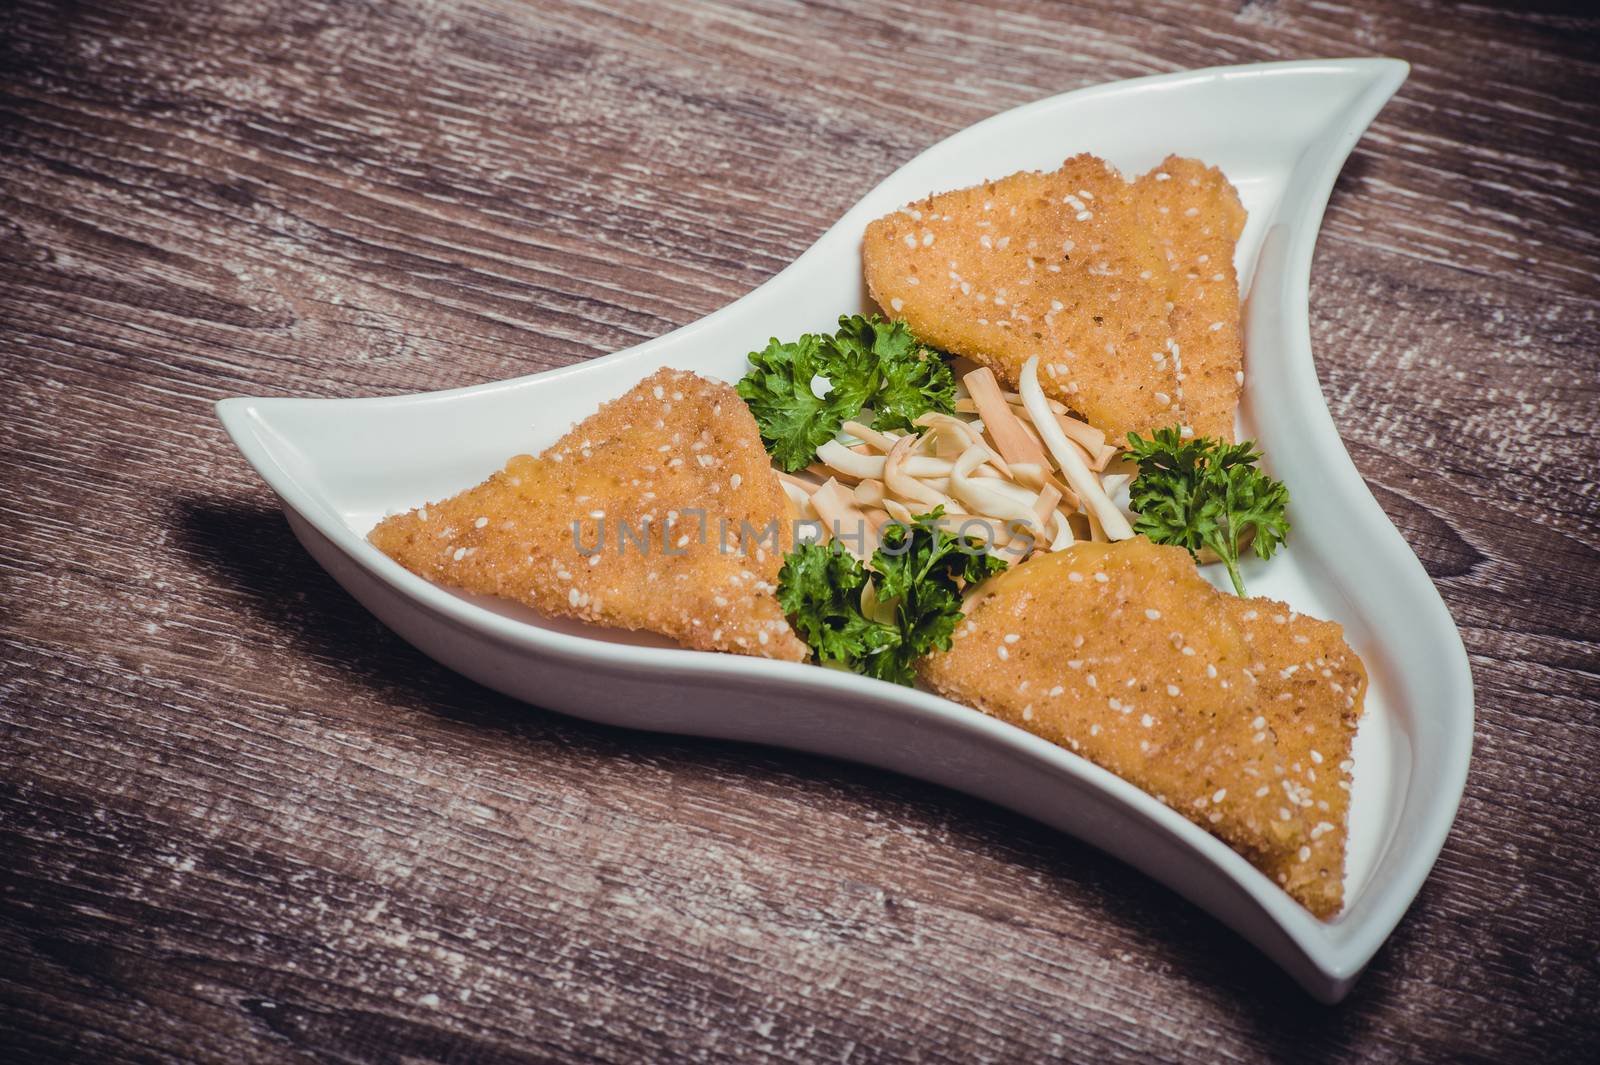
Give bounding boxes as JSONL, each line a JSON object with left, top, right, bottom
{"left": 1133, "top": 155, "right": 1245, "bottom": 440}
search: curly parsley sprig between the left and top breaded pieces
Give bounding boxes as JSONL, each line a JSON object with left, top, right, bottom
{"left": 736, "top": 315, "right": 955, "bottom": 473}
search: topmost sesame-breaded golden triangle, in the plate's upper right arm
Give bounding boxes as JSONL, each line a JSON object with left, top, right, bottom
{"left": 862, "top": 155, "right": 1243, "bottom": 443}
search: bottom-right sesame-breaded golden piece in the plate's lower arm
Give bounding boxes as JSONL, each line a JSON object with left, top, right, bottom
{"left": 920, "top": 537, "right": 1366, "bottom": 918}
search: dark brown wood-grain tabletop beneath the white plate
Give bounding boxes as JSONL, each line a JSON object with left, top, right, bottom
{"left": 0, "top": 0, "right": 1600, "bottom": 1063}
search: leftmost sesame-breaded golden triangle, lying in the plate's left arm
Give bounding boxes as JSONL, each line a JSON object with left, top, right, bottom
{"left": 368, "top": 369, "right": 808, "bottom": 662}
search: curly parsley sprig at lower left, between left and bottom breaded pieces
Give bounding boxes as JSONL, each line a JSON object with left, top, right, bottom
{"left": 778, "top": 507, "right": 1006, "bottom": 684}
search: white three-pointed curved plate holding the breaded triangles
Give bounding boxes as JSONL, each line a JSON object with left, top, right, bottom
{"left": 218, "top": 59, "right": 1472, "bottom": 1003}
